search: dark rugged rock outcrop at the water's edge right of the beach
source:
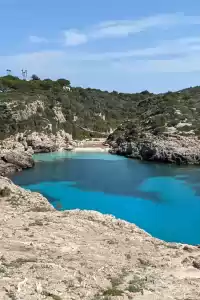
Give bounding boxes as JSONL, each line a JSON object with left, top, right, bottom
{"left": 107, "top": 125, "right": 200, "bottom": 165}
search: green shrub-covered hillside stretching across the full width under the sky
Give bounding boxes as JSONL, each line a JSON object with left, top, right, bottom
{"left": 0, "top": 75, "right": 200, "bottom": 139}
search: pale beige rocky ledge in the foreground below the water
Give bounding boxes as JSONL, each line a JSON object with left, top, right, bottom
{"left": 0, "top": 177, "right": 200, "bottom": 300}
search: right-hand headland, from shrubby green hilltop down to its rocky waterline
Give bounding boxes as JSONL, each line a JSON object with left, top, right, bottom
{"left": 107, "top": 88, "right": 200, "bottom": 165}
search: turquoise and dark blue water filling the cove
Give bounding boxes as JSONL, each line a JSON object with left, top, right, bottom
{"left": 12, "top": 153, "right": 200, "bottom": 244}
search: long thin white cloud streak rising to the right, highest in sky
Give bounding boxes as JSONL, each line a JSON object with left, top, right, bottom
{"left": 65, "top": 13, "right": 200, "bottom": 46}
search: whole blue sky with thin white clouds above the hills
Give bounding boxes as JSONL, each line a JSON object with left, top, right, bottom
{"left": 0, "top": 0, "right": 200, "bottom": 93}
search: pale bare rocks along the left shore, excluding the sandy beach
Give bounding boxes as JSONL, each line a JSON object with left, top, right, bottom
{"left": 0, "top": 130, "right": 75, "bottom": 176}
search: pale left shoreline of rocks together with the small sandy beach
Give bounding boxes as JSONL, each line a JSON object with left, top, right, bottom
{"left": 0, "top": 130, "right": 109, "bottom": 176}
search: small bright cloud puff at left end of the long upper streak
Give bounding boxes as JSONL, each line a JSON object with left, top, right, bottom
{"left": 64, "top": 29, "right": 88, "bottom": 46}
